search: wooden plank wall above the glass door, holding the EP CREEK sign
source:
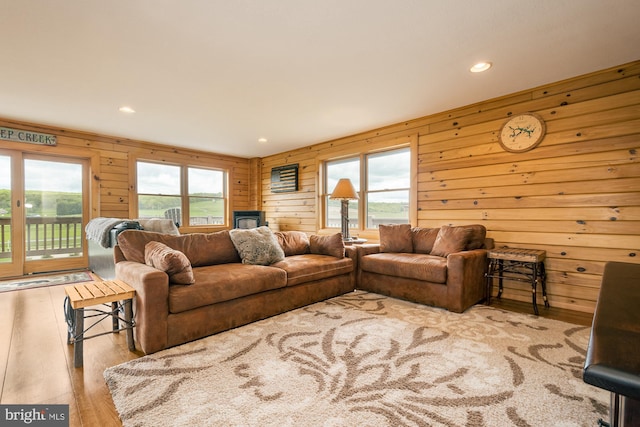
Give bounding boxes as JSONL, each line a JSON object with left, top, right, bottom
{"left": 0, "top": 118, "right": 250, "bottom": 233}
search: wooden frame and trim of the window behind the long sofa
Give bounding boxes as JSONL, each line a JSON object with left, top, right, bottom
{"left": 129, "top": 158, "right": 231, "bottom": 232}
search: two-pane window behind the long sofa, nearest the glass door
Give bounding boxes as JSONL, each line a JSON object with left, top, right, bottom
{"left": 137, "top": 162, "right": 227, "bottom": 226}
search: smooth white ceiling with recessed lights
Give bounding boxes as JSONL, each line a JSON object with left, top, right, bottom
{"left": 0, "top": 0, "right": 640, "bottom": 157}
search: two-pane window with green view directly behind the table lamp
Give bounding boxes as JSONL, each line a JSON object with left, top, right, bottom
{"left": 324, "top": 147, "right": 411, "bottom": 234}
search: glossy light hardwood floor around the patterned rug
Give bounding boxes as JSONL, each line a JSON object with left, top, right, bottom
{"left": 0, "top": 286, "right": 591, "bottom": 427}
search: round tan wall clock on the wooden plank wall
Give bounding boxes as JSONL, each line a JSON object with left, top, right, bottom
{"left": 498, "top": 113, "right": 546, "bottom": 153}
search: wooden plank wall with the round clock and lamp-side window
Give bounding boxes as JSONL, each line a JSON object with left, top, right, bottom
{"left": 260, "top": 61, "right": 640, "bottom": 313}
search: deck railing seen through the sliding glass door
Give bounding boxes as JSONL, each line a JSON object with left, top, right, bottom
{"left": 0, "top": 217, "right": 82, "bottom": 259}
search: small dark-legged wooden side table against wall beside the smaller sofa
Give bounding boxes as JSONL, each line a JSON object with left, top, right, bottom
{"left": 485, "top": 248, "right": 549, "bottom": 316}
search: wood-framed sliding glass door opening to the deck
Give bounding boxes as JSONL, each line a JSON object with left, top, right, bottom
{"left": 0, "top": 150, "right": 89, "bottom": 278}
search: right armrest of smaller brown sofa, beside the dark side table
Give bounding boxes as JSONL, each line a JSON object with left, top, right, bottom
{"left": 447, "top": 249, "right": 487, "bottom": 313}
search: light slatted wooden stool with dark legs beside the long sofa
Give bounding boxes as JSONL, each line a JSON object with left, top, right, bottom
{"left": 64, "top": 280, "right": 136, "bottom": 368}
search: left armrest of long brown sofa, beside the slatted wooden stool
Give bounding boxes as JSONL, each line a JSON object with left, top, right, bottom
{"left": 116, "top": 261, "right": 169, "bottom": 354}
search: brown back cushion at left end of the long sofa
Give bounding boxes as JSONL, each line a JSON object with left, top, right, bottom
{"left": 118, "top": 230, "right": 240, "bottom": 267}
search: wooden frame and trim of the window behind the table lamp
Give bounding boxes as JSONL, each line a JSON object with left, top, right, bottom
{"left": 317, "top": 134, "right": 418, "bottom": 240}
